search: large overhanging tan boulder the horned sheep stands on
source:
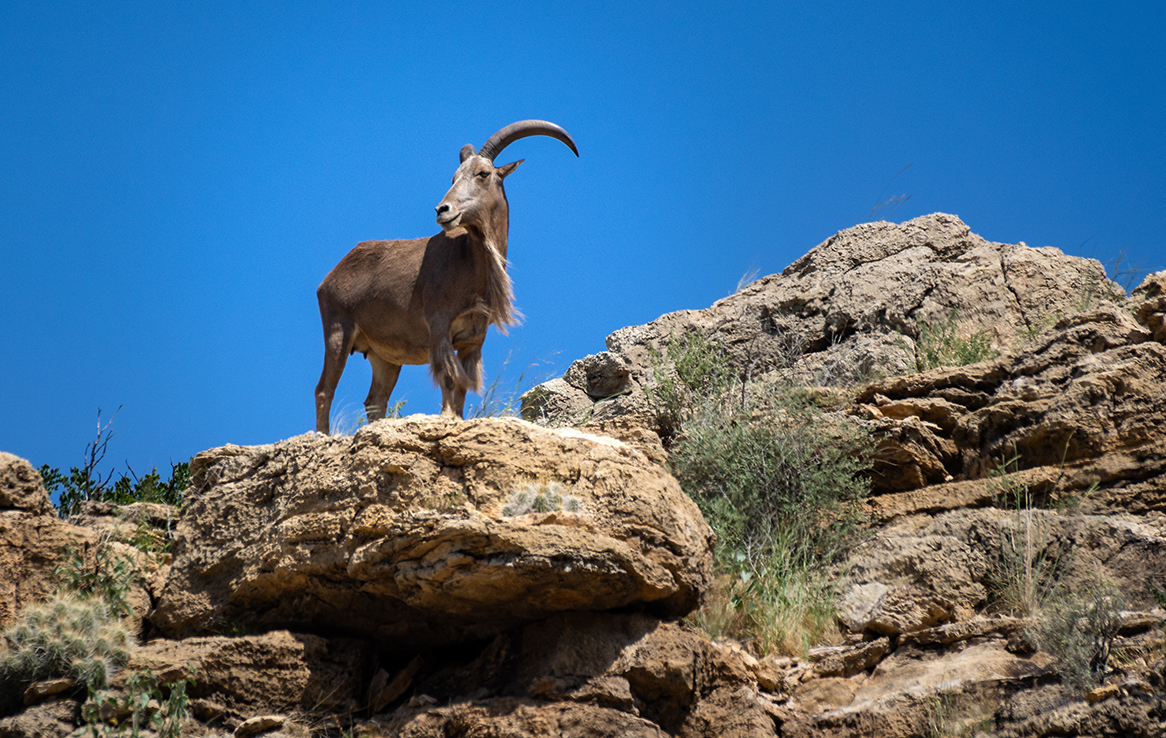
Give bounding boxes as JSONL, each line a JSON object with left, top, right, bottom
{"left": 152, "top": 416, "right": 711, "bottom": 648}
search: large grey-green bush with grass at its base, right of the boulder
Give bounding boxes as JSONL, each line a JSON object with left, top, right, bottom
{"left": 653, "top": 333, "right": 869, "bottom": 653}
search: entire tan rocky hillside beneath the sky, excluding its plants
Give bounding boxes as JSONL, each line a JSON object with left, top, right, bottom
{"left": 0, "top": 215, "right": 1166, "bottom": 738}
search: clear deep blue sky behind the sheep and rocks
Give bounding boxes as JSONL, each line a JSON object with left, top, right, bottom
{"left": 0, "top": 0, "right": 1166, "bottom": 475}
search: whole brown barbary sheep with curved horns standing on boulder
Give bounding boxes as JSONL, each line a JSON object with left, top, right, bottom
{"left": 316, "top": 120, "right": 578, "bottom": 434}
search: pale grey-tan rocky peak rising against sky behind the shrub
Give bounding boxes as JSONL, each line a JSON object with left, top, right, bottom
{"left": 522, "top": 213, "right": 1124, "bottom": 427}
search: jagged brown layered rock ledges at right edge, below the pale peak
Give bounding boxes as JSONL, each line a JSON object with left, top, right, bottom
{"left": 857, "top": 307, "right": 1166, "bottom": 494}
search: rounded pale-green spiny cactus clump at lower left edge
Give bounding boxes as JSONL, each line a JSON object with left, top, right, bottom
{"left": 0, "top": 593, "right": 134, "bottom": 714}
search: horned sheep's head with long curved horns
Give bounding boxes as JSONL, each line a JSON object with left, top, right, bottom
{"left": 437, "top": 120, "right": 580, "bottom": 233}
